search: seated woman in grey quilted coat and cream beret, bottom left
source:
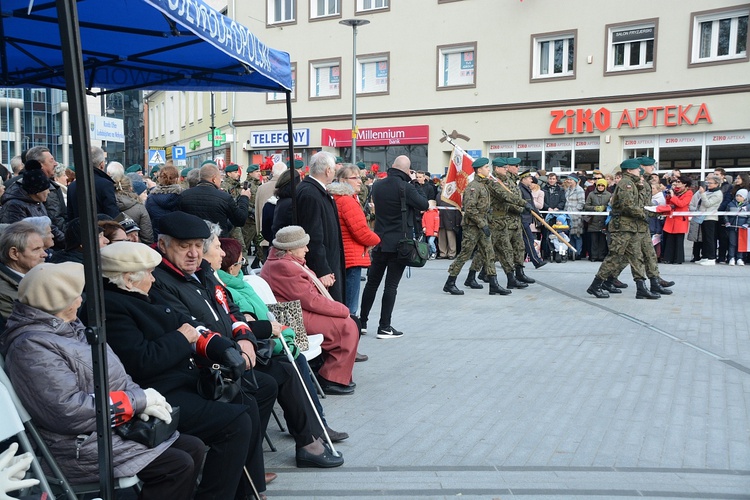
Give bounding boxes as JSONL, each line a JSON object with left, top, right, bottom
{"left": 0, "top": 262, "right": 205, "bottom": 499}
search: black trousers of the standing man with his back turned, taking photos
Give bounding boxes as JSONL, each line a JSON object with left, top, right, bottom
{"left": 359, "top": 248, "right": 406, "bottom": 328}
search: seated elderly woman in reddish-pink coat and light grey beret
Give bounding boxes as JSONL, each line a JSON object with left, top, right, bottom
{"left": 260, "top": 226, "right": 359, "bottom": 395}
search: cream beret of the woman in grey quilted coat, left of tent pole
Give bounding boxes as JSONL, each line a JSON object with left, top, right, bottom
{"left": 18, "top": 262, "right": 85, "bottom": 314}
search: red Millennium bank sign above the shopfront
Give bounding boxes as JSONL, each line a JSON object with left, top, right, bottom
{"left": 320, "top": 125, "right": 430, "bottom": 148}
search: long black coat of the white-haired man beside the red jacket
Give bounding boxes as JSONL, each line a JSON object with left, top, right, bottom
{"left": 296, "top": 177, "right": 346, "bottom": 303}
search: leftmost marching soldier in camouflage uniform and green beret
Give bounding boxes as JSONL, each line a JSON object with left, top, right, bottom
{"left": 443, "top": 158, "right": 507, "bottom": 295}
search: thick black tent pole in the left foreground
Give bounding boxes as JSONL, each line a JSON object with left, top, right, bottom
{"left": 56, "top": 0, "right": 114, "bottom": 500}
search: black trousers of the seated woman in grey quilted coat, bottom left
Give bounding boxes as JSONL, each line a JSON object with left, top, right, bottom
{"left": 138, "top": 434, "right": 206, "bottom": 500}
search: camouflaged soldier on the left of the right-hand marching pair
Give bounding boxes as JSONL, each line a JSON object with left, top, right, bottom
{"left": 586, "top": 159, "right": 659, "bottom": 299}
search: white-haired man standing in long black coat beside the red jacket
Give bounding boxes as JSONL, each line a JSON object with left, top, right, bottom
{"left": 296, "top": 151, "right": 346, "bottom": 304}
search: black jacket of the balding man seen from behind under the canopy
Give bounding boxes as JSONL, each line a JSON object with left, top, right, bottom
{"left": 177, "top": 181, "right": 250, "bottom": 238}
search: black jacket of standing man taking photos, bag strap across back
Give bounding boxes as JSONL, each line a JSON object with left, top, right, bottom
{"left": 372, "top": 168, "right": 429, "bottom": 252}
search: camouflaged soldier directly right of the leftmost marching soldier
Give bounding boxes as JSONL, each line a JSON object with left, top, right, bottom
{"left": 472, "top": 157, "right": 529, "bottom": 293}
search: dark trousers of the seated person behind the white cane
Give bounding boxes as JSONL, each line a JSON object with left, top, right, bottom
{"left": 256, "top": 356, "right": 323, "bottom": 448}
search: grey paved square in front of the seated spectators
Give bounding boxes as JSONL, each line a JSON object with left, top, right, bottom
{"left": 265, "top": 260, "right": 750, "bottom": 499}
